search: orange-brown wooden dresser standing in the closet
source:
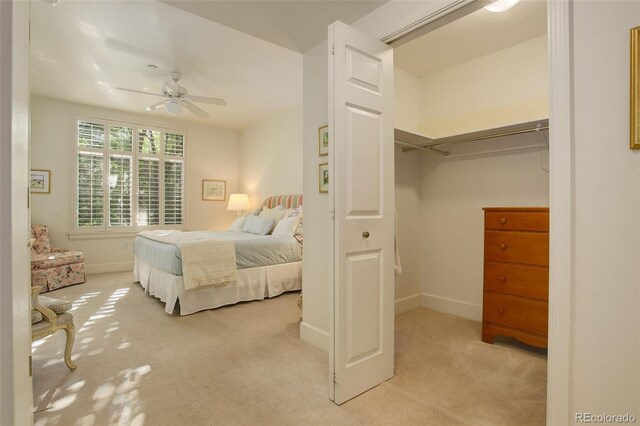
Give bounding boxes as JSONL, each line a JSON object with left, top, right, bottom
{"left": 482, "top": 207, "right": 549, "bottom": 347}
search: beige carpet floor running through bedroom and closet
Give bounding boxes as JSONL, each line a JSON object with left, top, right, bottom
{"left": 33, "top": 273, "right": 546, "bottom": 426}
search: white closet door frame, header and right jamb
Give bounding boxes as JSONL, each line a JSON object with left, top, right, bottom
{"left": 353, "top": 0, "right": 575, "bottom": 424}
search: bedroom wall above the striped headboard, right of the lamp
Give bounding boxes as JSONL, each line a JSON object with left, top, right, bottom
{"left": 240, "top": 106, "right": 306, "bottom": 207}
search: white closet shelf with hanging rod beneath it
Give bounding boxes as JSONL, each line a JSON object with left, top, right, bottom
{"left": 394, "top": 119, "right": 549, "bottom": 155}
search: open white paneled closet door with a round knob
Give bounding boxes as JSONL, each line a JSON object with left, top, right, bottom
{"left": 329, "top": 22, "right": 394, "bottom": 404}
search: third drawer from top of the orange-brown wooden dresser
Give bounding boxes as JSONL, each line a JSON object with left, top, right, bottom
{"left": 484, "top": 262, "right": 549, "bottom": 301}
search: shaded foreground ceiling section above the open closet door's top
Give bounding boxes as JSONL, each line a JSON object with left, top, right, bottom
{"left": 161, "top": 0, "right": 388, "bottom": 52}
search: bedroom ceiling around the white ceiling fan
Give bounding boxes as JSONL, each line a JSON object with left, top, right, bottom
{"left": 31, "top": 1, "right": 302, "bottom": 129}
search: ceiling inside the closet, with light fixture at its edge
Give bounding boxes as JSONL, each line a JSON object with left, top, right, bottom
{"left": 393, "top": 0, "right": 547, "bottom": 77}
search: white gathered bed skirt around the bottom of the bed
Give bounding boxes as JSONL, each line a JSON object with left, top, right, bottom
{"left": 133, "top": 257, "right": 302, "bottom": 315}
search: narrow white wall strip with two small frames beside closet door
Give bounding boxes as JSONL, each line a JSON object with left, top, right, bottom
{"left": 300, "top": 41, "right": 333, "bottom": 351}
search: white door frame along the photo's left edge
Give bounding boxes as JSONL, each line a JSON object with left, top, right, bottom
{"left": 0, "top": 0, "right": 33, "bottom": 424}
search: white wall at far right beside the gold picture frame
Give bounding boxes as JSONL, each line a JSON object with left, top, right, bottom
{"left": 558, "top": 1, "right": 640, "bottom": 422}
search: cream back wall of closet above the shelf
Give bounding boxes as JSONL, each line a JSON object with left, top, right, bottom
{"left": 420, "top": 35, "right": 549, "bottom": 137}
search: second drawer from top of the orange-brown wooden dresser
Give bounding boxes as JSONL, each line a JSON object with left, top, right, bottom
{"left": 484, "top": 231, "right": 549, "bottom": 266}
